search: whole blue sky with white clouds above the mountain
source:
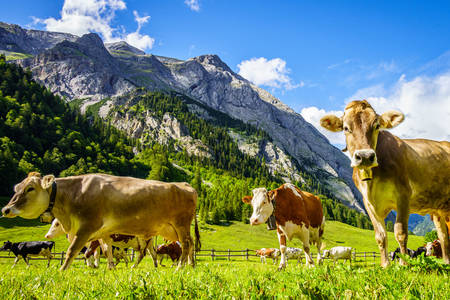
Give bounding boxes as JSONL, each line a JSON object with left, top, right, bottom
{"left": 0, "top": 0, "right": 450, "bottom": 146}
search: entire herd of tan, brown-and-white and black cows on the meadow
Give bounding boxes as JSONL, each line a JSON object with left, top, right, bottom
{"left": 2, "top": 100, "right": 450, "bottom": 270}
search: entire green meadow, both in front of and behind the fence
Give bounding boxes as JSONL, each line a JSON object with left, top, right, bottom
{"left": 0, "top": 212, "right": 450, "bottom": 299}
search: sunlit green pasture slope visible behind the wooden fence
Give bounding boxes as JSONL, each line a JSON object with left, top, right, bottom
{"left": 0, "top": 221, "right": 424, "bottom": 253}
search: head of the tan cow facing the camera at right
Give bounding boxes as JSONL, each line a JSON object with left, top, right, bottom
{"left": 320, "top": 100, "right": 405, "bottom": 180}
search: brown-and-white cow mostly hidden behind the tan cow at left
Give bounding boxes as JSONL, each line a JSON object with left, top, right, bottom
{"left": 45, "top": 218, "right": 157, "bottom": 268}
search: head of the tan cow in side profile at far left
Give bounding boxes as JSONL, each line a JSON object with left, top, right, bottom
{"left": 2, "top": 172, "right": 55, "bottom": 219}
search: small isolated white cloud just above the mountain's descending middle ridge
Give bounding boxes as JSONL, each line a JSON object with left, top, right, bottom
{"left": 238, "top": 57, "right": 305, "bottom": 90}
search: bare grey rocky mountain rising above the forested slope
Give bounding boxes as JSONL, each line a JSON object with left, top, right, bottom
{"left": 0, "top": 23, "right": 362, "bottom": 211}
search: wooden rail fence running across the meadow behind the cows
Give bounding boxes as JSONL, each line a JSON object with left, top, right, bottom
{"left": 0, "top": 249, "right": 380, "bottom": 265}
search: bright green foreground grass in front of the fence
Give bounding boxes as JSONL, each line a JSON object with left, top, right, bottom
{"left": 0, "top": 258, "right": 450, "bottom": 299}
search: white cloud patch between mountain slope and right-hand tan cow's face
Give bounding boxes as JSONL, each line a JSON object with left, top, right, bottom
{"left": 300, "top": 106, "right": 345, "bottom": 146}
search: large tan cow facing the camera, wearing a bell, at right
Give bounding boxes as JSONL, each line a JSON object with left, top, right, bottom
{"left": 320, "top": 100, "right": 450, "bottom": 267}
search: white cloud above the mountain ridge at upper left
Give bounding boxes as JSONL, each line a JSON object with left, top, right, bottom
{"left": 34, "top": 0, "right": 154, "bottom": 50}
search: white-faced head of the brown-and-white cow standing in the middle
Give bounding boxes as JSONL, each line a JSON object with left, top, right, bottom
{"left": 242, "top": 188, "right": 273, "bottom": 225}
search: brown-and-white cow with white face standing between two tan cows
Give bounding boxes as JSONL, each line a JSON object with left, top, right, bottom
{"left": 242, "top": 183, "right": 325, "bottom": 269}
